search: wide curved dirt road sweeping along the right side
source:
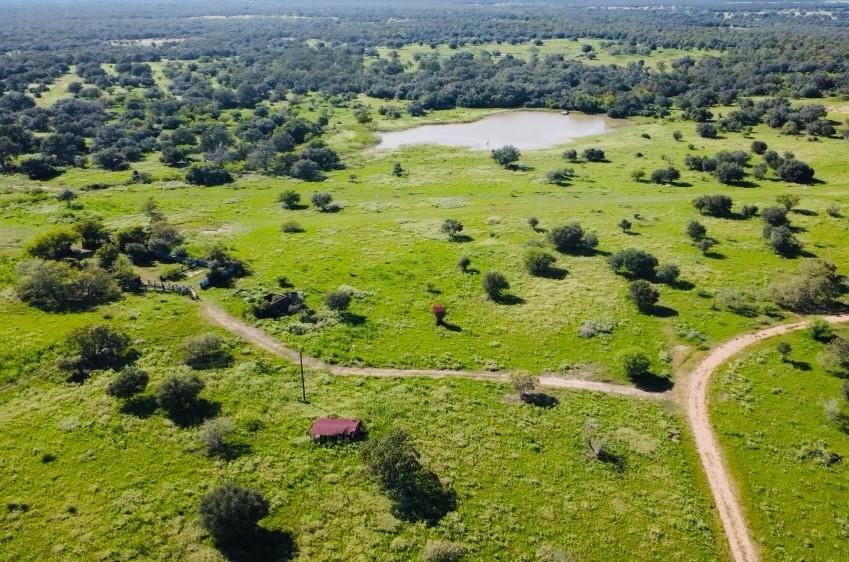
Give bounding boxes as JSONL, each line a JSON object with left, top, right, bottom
{"left": 684, "top": 315, "right": 849, "bottom": 562}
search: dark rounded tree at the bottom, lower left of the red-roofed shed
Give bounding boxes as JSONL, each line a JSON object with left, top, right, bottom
{"left": 199, "top": 482, "right": 269, "bottom": 545}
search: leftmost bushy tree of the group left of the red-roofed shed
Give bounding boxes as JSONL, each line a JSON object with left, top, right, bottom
{"left": 65, "top": 324, "right": 133, "bottom": 371}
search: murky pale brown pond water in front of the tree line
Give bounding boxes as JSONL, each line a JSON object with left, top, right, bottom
{"left": 377, "top": 111, "right": 627, "bottom": 150}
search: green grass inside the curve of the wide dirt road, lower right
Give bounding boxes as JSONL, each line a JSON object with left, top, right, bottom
{"left": 711, "top": 329, "right": 849, "bottom": 561}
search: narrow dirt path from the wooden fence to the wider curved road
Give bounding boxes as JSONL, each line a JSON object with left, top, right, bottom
{"left": 201, "top": 301, "right": 669, "bottom": 400}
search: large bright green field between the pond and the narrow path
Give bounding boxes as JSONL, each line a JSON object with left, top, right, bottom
{"left": 0, "top": 100, "right": 849, "bottom": 380}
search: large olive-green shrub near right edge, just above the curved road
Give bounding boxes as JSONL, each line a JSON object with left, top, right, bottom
{"left": 772, "top": 259, "right": 843, "bottom": 312}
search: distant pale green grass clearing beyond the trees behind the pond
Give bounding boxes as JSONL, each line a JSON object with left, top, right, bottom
{"left": 366, "top": 38, "right": 720, "bottom": 68}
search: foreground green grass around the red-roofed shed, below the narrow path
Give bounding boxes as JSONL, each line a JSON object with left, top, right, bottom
{"left": 0, "top": 295, "right": 725, "bottom": 561}
